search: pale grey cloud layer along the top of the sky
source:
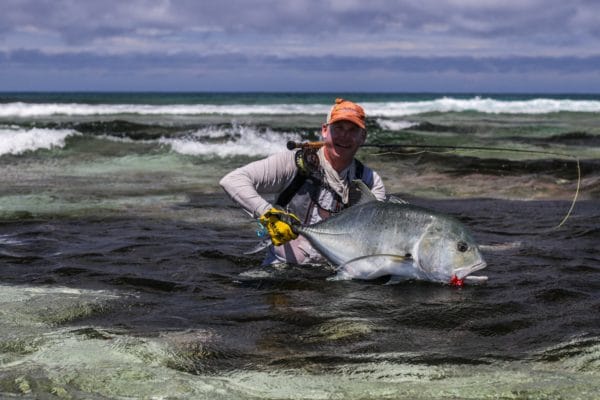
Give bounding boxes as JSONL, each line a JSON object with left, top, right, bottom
{"left": 0, "top": 0, "right": 600, "bottom": 46}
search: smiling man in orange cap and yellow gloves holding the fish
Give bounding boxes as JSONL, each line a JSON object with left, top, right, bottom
{"left": 220, "top": 99, "right": 385, "bottom": 265}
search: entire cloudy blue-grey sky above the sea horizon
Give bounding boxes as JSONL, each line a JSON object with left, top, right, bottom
{"left": 0, "top": 0, "right": 600, "bottom": 93}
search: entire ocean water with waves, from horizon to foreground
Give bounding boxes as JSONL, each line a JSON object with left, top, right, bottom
{"left": 0, "top": 93, "right": 600, "bottom": 399}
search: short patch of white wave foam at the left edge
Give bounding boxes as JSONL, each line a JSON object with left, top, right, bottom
{"left": 0, "top": 128, "right": 77, "bottom": 156}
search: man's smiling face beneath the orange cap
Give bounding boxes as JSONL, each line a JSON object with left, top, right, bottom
{"left": 322, "top": 120, "right": 367, "bottom": 163}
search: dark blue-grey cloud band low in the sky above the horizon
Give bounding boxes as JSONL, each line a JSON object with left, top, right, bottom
{"left": 0, "top": 49, "right": 600, "bottom": 74}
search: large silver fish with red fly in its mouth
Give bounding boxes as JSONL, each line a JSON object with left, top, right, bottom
{"left": 295, "top": 181, "right": 487, "bottom": 286}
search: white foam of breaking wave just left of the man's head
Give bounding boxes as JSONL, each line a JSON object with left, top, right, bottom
{"left": 160, "top": 126, "right": 300, "bottom": 158}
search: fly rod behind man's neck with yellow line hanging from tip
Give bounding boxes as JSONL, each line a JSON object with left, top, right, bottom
{"left": 286, "top": 140, "right": 581, "bottom": 229}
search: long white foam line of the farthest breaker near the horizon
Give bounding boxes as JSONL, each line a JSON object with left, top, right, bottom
{"left": 0, "top": 96, "right": 600, "bottom": 117}
